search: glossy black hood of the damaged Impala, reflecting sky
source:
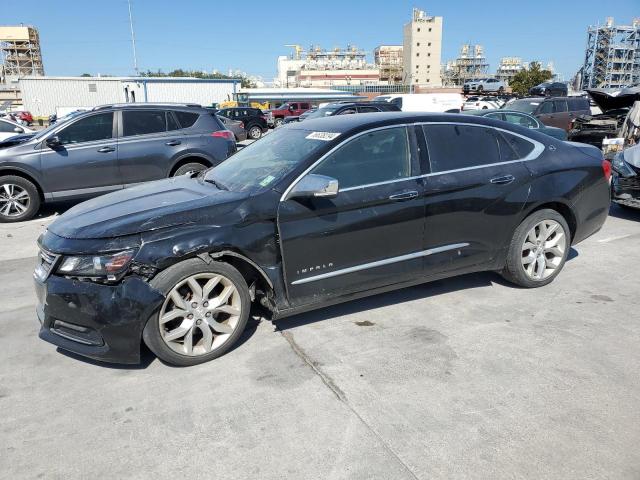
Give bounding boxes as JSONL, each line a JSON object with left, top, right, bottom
{"left": 49, "top": 176, "right": 247, "bottom": 239}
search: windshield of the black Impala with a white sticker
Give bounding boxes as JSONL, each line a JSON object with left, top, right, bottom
{"left": 204, "top": 127, "right": 335, "bottom": 193}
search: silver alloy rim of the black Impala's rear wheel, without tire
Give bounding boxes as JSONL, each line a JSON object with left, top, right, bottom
{"left": 522, "top": 220, "right": 567, "bottom": 280}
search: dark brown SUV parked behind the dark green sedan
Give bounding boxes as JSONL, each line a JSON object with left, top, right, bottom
{"left": 502, "top": 97, "right": 591, "bottom": 132}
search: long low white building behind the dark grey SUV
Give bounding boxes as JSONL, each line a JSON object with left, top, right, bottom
{"left": 19, "top": 76, "right": 240, "bottom": 117}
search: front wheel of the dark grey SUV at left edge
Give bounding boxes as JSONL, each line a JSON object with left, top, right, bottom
{"left": 0, "top": 175, "right": 41, "bottom": 223}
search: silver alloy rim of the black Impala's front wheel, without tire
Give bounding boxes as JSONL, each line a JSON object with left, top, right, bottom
{"left": 158, "top": 273, "right": 242, "bottom": 357}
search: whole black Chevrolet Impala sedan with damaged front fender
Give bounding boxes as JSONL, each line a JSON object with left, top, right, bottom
{"left": 34, "top": 113, "right": 610, "bottom": 365}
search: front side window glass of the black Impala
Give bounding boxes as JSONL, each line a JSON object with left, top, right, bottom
{"left": 312, "top": 127, "right": 411, "bottom": 189}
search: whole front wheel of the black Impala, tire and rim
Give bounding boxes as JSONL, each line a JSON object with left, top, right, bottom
{"left": 142, "top": 258, "right": 251, "bottom": 367}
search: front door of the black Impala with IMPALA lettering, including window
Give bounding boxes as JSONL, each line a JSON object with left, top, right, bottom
{"left": 278, "top": 126, "right": 425, "bottom": 306}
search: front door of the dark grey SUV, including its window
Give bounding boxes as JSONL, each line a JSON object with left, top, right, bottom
{"left": 40, "top": 112, "right": 122, "bottom": 199}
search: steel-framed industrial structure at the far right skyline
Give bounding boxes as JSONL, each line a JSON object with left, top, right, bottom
{"left": 581, "top": 17, "right": 640, "bottom": 89}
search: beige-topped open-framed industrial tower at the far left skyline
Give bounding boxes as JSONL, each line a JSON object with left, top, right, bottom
{"left": 0, "top": 26, "right": 44, "bottom": 82}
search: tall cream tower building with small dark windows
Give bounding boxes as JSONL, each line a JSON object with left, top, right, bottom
{"left": 402, "top": 8, "right": 442, "bottom": 87}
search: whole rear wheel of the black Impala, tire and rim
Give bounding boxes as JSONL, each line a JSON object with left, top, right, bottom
{"left": 502, "top": 209, "right": 571, "bottom": 288}
